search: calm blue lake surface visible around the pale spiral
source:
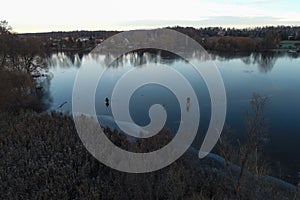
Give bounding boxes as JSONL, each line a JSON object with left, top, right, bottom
{"left": 43, "top": 51, "right": 300, "bottom": 179}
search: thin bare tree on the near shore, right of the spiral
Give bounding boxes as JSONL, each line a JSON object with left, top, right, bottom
{"left": 220, "top": 93, "right": 268, "bottom": 199}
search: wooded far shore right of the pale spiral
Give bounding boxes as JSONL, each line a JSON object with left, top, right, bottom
{"left": 168, "top": 26, "right": 300, "bottom": 52}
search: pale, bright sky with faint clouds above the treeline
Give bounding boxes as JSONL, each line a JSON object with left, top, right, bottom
{"left": 0, "top": 0, "right": 300, "bottom": 33}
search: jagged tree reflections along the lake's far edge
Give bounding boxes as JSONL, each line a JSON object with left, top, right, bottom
{"left": 46, "top": 49, "right": 299, "bottom": 73}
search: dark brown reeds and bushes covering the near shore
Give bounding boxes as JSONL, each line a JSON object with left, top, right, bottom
{"left": 0, "top": 111, "right": 299, "bottom": 199}
